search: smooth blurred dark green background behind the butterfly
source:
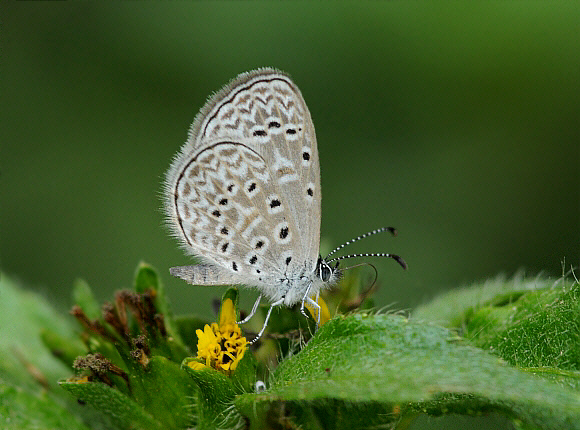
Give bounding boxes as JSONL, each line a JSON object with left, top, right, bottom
{"left": 0, "top": 1, "right": 580, "bottom": 316}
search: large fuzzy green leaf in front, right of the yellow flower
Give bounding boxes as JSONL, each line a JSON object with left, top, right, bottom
{"left": 236, "top": 314, "right": 580, "bottom": 428}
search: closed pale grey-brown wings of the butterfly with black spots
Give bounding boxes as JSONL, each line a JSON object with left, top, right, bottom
{"left": 166, "top": 69, "right": 321, "bottom": 296}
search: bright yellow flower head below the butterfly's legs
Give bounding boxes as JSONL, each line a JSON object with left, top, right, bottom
{"left": 196, "top": 299, "right": 247, "bottom": 372}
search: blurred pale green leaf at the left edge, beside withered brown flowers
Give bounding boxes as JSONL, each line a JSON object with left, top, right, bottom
{"left": 0, "top": 273, "right": 104, "bottom": 429}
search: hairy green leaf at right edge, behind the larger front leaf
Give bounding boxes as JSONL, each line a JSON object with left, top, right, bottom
{"left": 415, "top": 278, "right": 580, "bottom": 387}
